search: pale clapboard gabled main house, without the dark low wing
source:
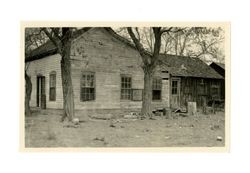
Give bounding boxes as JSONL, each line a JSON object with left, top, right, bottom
{"left": 25, "top": 28, "right": 172, "bottom": 116}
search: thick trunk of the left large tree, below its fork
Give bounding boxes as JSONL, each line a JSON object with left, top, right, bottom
{"left": 61, "top": 40, "right": 75, "bottom": 121}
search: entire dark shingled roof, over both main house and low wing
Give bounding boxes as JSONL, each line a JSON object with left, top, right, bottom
{"left": 25, "top": 27, "right": 222, "bottom": 79}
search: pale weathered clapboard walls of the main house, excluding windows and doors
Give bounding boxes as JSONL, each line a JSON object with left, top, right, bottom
{"left": 26, "top": 28, "right": 172, "bottom": 113}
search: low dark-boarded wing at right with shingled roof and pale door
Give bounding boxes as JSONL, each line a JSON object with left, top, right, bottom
{"left": 160, "top": 55, "right": 224, "bottom": 109}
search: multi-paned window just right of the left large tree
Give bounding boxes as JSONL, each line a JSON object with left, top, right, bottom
{"left": 80, "top": 71, "right": 96, "bottom": 102}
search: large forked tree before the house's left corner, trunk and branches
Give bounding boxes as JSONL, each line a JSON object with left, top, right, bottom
{"left": 41, "top": 27, "right": 90, "bottom": 121}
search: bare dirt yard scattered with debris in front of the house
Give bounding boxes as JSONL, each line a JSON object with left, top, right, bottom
{"left": 25, "top": 112, "right": 225, "bottom": 147}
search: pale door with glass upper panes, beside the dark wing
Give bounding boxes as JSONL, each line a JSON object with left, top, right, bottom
{"left": 171, "top": 78, "right": 180, "bottom": 109}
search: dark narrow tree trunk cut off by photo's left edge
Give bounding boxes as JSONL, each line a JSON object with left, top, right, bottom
{"left": 25, "top": 71, "right": 32, "bottom": 116}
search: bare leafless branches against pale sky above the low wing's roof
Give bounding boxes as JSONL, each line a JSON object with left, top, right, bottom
{"left": 162, "top": 27, "right": 225, "bottom": 62}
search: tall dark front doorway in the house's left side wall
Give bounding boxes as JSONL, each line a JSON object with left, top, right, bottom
{"left": 36, "top": 76, "right": 46, "bottom": 109}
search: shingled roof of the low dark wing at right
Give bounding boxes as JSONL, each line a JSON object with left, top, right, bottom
{"left": 160, "top": 54, "right": 223, "bottom": 79}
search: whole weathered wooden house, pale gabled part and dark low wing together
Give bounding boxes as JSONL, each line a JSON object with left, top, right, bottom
{"left": 25, "top": 28, "right": 223, "bottom": 113}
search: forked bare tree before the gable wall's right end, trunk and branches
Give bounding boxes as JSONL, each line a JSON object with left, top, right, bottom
{"left": 127, "top": 27, "right": 180, "bottom": 115}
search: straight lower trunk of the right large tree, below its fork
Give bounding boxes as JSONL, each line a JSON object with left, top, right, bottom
{"left": 141, "top": 69, "right": 153, "bottom": 116}
